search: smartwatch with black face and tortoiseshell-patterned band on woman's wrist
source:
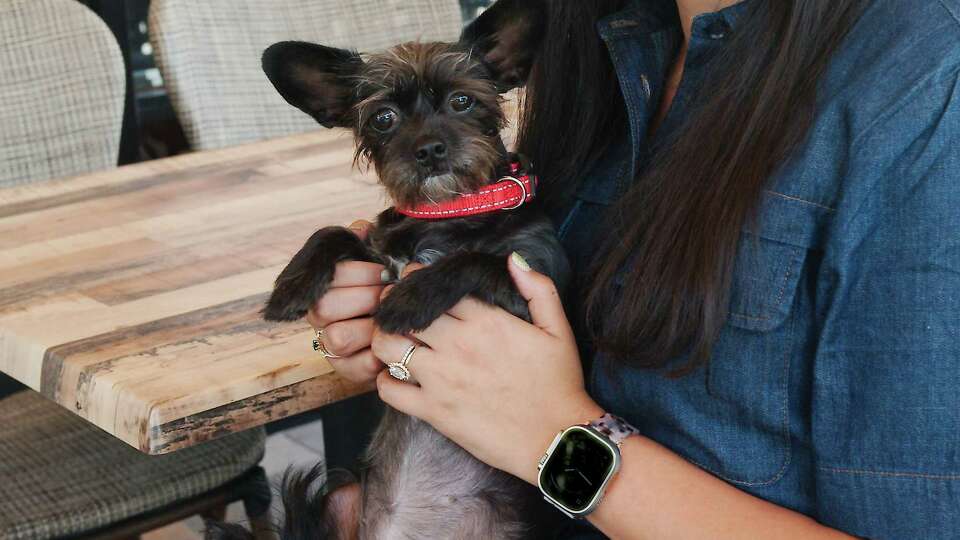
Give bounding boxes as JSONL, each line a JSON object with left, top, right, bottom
{"left": 537, "top": 413, "right": 639, "bottom": 519}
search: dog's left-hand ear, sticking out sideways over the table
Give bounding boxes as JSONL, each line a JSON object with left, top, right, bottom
{"left": 262, "top": 41, "right": 363, "bottom": 127}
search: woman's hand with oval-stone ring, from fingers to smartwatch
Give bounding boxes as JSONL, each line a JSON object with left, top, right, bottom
{"left": 373, "top": 253, "right": 602, "bottom": 483}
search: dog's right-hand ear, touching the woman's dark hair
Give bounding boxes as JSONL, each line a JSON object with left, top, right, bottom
{"left": 460, "top": 0, "right": 544, "bottom": 92}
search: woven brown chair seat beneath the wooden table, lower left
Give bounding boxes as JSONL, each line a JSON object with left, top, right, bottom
{"left": 0, "top": 390, "right": 270, "bottom": 540}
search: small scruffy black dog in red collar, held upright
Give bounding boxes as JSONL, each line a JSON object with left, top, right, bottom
{"left": 212, "top": 0, "right": 569, "bottom": 540}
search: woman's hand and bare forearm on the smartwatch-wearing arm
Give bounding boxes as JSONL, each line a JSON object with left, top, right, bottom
{"left": 373, "top": 258, "right": 860, "bottom": 538}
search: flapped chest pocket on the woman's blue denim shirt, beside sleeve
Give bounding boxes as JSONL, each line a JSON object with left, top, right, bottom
{"left": 694, "top": 192, "right": 832, "bottom": 487}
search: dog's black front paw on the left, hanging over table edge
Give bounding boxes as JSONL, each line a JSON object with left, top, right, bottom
{"left": 262, "top": 227, "right": 376, "bottom": 321}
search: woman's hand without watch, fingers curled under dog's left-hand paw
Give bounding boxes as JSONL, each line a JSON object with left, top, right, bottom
{"left": 306, "top": 221, "right": 384, "bottom": 383}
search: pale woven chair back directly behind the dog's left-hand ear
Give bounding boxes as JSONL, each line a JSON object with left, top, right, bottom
{"left": 149, "top": 0, "right": 461, "bottom": 150}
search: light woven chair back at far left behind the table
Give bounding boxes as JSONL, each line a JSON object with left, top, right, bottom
{"left": 0, "top": 0, "right": 125, "bottom": 187}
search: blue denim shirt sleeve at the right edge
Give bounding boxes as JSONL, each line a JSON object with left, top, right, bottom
{"left": 811, "top": 66, "right": 960, "bottom": 538}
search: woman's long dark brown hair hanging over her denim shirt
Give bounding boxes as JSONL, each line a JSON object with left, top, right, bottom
{"left": 519, "top": 0, "right": 869, "bottom": 374}
